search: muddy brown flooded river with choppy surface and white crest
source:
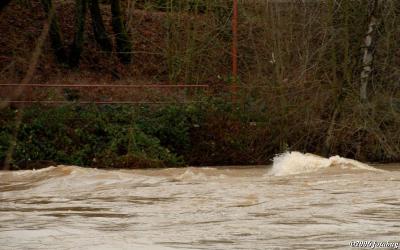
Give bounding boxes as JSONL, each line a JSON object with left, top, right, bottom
{"left": 0, "top": 152, "right": 400, "bottom": 249}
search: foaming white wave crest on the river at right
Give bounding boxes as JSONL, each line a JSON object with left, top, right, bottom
{"left": 271, "top": 152, "right": 379, "bottom": 176}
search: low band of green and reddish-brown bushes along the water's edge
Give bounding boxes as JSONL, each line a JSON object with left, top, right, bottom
{"left": 0, "top": 99, "right": 400, "bottom": 169}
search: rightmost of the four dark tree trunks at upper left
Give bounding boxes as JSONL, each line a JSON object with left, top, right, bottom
{"left": 111, "top": 0, "right": 132, "bottom": 64}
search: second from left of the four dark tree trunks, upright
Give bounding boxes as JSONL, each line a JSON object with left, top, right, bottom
{"left": 69, "top": 0, "right": 87, "bottom": 67}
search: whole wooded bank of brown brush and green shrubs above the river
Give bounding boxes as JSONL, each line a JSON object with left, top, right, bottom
{"left": 0, "top": 0, "right": 400, "bottom": 169}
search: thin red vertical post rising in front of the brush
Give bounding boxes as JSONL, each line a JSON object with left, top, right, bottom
{"left": 232, "top": 0, "right": 238, "bottom": 101}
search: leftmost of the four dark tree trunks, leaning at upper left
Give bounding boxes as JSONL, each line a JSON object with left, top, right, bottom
{"left": 40, "top": 0, "right": 67, "bottom": 63}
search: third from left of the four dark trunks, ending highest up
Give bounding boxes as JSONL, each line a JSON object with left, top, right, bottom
{"left": 89, "top": 0, "right": 112, "bottom": 52}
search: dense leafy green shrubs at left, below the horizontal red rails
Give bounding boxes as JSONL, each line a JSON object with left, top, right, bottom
{"left": 0, "top": 106, "right": 184, "bottom": 168}
